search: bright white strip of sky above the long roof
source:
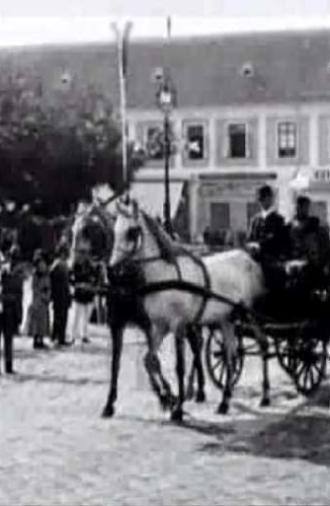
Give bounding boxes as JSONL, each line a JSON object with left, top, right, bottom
{"left": 0, "top": 0, "right": 330, "bottom": 46}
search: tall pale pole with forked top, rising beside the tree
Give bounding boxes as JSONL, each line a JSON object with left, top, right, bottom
{"left": 111, "top": 22, "right": 132, "bottom": 190}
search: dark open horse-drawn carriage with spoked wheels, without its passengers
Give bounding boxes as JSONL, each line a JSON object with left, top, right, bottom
{"left": 198, "top": 256, "right": 330, "bottom": 396}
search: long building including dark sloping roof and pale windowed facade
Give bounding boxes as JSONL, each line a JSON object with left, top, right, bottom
{"left": 0, "top": 31, "right": 330, "bottom": 240}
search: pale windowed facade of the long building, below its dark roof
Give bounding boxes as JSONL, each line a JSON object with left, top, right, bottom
{"left": 130, "top": 102, "right": 330, "bottom": 238}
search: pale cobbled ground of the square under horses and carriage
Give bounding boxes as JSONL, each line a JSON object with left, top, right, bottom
{"left": 0, "top": 324, "right": 330, "bottom": 506}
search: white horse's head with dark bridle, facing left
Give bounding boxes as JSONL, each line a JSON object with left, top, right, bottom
{"left": 110, "top": 197, "right": 142, "bottom": 266}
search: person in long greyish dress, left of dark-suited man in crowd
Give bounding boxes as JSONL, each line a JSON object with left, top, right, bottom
{"left": 29, "top": 250, "right": 51, "bottom": 349}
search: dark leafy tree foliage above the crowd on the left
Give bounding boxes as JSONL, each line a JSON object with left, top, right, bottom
{"left": 0, "top": 70, "right": 142, "bottom": 215}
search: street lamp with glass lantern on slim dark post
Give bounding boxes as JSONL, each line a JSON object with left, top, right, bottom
{"left": 157, "top": 76, "right": 175, "bottom": 235}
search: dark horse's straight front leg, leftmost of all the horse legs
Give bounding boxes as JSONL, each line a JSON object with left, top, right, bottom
{"left": 102, "top": 323, "right": 124, "bottom": 418}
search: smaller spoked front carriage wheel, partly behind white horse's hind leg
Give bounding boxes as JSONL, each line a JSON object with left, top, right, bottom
{"left": 204, "top": 328, "right": 244, "bottom": 389}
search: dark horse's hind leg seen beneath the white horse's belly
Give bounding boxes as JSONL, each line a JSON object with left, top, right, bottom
{"left": 186, "top": 327, "right": 206, "bottom": 402}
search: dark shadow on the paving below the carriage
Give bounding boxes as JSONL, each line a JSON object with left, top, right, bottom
{"left": 183, "top": 385, "right": 330, "bottom": 467}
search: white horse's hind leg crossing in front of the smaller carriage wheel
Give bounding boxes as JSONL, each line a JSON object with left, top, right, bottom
{"left": 217, "top": 321, "right": 237, "bottom": 415}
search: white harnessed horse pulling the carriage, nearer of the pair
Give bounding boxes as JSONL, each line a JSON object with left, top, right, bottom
{"left": 105, "top": 199, "right": 269, "bottom": 420}
